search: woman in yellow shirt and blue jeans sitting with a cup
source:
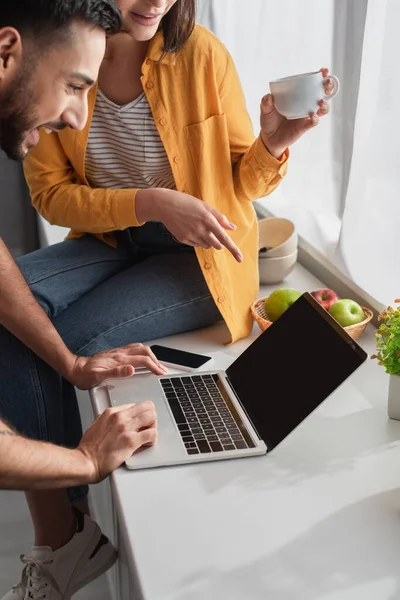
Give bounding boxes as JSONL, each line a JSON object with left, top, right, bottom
{"left": 0, "top": 0, "right": 329, "bottom": 592}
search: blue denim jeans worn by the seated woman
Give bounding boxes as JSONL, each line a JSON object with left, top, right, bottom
{"left": 0, "top": 223, "right": 221, "bottom": 502}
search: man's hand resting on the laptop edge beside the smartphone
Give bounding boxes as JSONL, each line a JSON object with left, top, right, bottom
{"left": 65, "top": 344, "right": 168, "bottom": 390}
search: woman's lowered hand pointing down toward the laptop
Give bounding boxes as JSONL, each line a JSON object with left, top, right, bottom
{"left": 136, "top": 188, "right": 243, "bottom": 262}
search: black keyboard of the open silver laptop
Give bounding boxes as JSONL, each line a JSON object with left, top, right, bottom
{"left": 160, "top": 375, "right": 255, "bottom": 454}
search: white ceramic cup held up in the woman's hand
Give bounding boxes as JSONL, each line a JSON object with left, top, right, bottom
{"left": 269, "top": 71, "right": 340, "bottom": 119}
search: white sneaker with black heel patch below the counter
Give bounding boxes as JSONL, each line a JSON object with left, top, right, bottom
{"left": 2, "top": 513, "right": 117, "bottom": 600}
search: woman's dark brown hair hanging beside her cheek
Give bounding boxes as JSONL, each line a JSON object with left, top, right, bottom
{"left": 161, "top": 0, "right": 196, "bottom": 54}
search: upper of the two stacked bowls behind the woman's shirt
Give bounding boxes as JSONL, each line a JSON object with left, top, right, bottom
{"left": 258, "top": 217, "right": 298, "bottom": 258}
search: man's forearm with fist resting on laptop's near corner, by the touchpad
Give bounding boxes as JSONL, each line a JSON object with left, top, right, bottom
{"left": 0, "top": 402, "right": 157, "bottom": 490}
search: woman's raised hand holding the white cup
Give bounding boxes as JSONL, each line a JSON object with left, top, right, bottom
{"left": 260, "top": 69, "right": 334, "bottom": 159}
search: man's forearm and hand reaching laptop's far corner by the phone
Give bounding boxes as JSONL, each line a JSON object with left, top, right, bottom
{"left": 0, "top": 239, "right": 166, "bottom": 389}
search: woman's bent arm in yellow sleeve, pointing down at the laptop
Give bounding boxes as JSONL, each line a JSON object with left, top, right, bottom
{"left": 25, "top": 133, "right": 242, "bottom": 262}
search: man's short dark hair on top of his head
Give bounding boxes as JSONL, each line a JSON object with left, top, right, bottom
{"left": 0, "top": 0, "right": 121, "bottom": 45}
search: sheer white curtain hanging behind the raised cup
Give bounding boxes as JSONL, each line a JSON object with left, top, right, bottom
{"left": 198, "top": 0, "right": 400, "bottom": 304}
